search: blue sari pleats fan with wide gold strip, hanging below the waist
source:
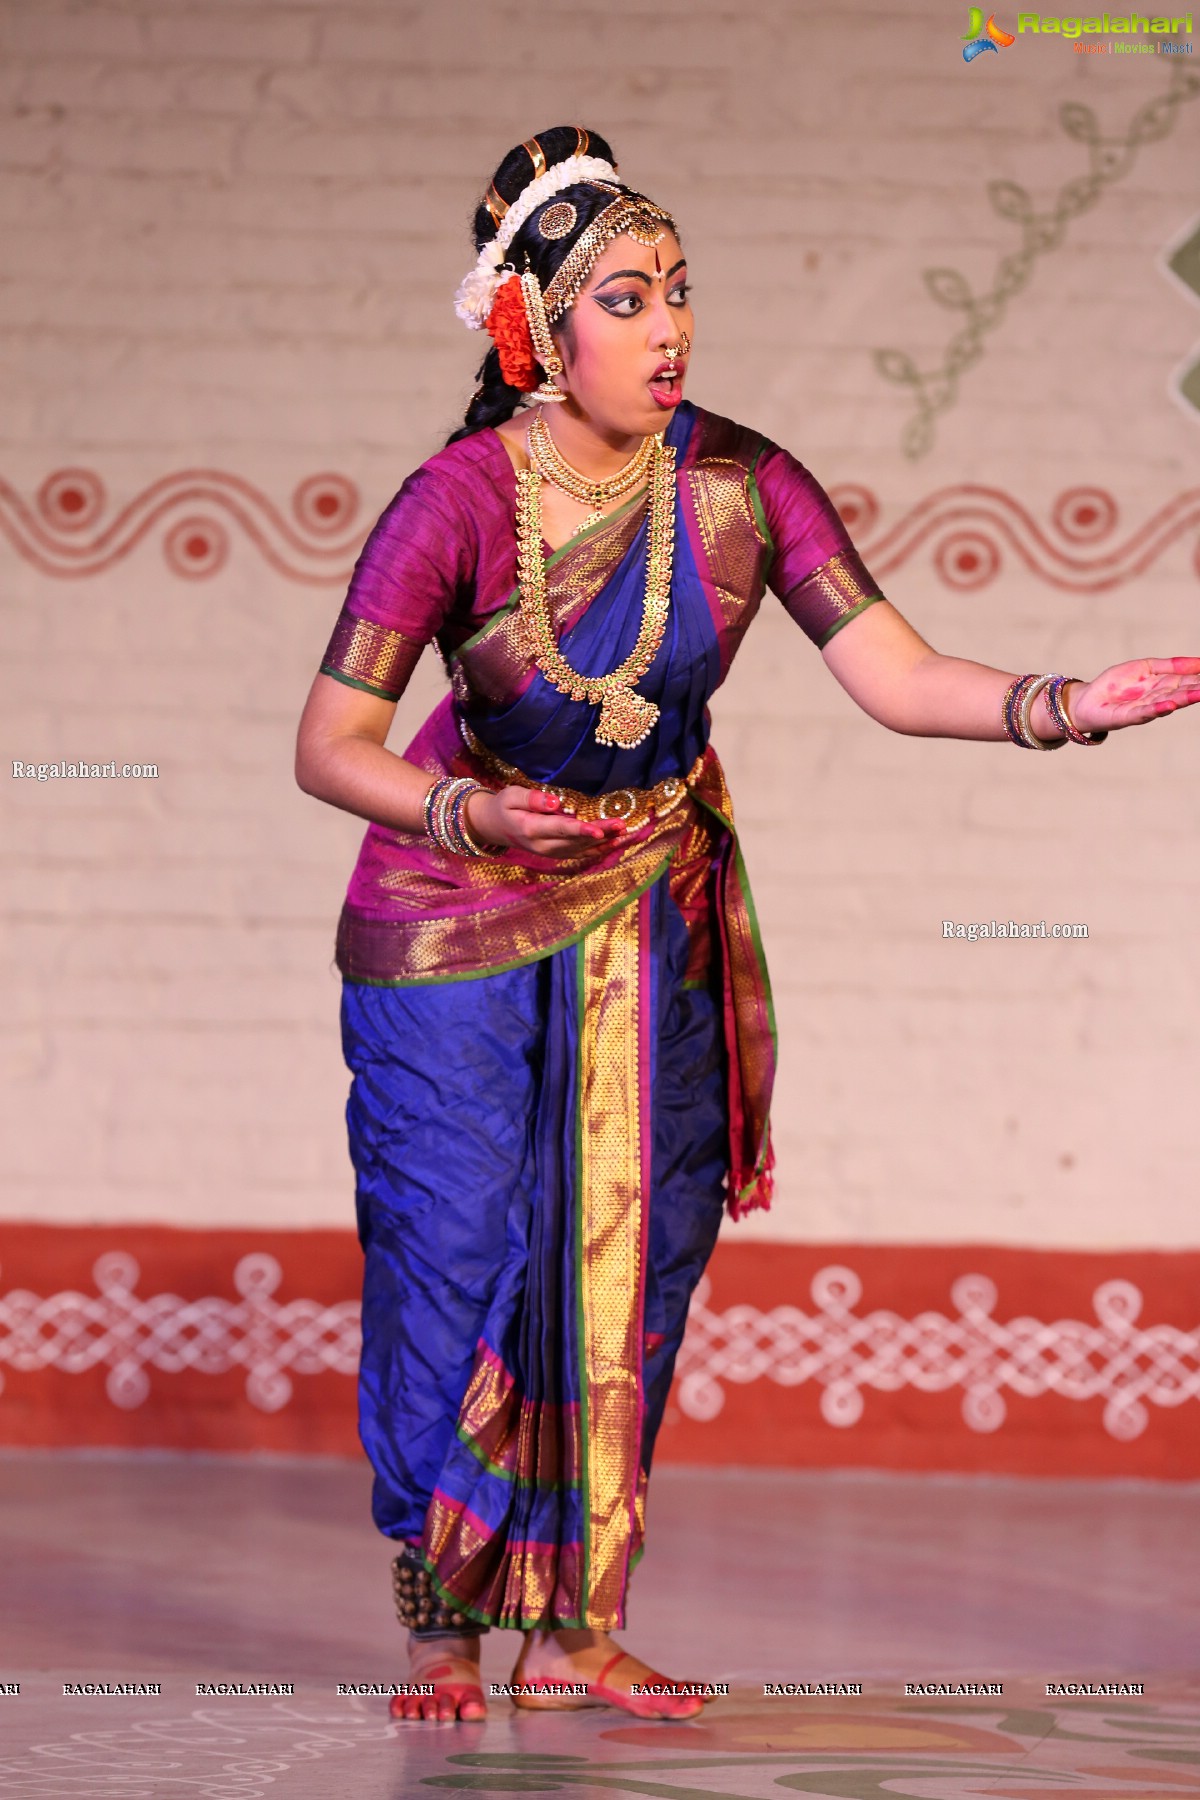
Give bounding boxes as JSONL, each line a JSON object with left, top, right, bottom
{"left": 415, "top": 895, "right": 657, "bottom": 1627}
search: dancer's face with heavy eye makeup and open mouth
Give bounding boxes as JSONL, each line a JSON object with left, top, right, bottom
{"left": 554, "top": 230, "right": 694, "bottom": 443}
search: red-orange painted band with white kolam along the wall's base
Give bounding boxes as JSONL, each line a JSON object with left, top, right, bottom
{"left": 0, "top": 1222, "right": 1200, "bottom": 1480}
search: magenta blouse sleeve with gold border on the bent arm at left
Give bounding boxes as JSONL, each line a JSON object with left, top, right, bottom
{"left": 320, "top": 464, "right": 475, "bottom": 700}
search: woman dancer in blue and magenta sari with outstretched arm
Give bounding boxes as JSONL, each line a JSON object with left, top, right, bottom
{"left": 297, "top": 126, "right": 1200, "bottom": 1719}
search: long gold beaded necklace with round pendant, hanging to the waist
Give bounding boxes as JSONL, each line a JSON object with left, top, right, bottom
{"left": 516, "top": 427, "right": 675, "bottom": 751}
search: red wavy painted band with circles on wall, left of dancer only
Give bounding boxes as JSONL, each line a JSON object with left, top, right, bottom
{"left": 0, "top": 468, "right": 362, "bottom": 587}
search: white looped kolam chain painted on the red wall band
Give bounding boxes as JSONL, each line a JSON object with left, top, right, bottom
{"left": 0, "top": 1251, "right": 1200, "bottom": 1442}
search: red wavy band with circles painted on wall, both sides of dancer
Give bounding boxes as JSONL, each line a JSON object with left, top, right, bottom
{"left": 0, "top": 468, "right": 1200, "bottom": 592}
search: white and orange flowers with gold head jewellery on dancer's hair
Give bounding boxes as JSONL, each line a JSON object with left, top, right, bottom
{"left": 453, "top": 126, "right": 675, "bottom": 401}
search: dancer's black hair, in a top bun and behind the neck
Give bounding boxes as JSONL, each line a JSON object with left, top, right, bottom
{"left": 446, "top": 124, "right": 672, "bottom": 445}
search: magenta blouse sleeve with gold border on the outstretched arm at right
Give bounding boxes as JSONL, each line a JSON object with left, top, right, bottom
{"left": 750, "top": 439, "right": 883, "bottom": 650}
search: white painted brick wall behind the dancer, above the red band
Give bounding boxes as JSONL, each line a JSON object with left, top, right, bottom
{"left": 0, "top": 0, "right": 1200, "bottom": 1246}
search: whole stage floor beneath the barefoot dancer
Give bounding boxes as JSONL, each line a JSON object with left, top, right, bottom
{"left": 0, "top": 1451, "right": 1200, "bottom": 1800}
